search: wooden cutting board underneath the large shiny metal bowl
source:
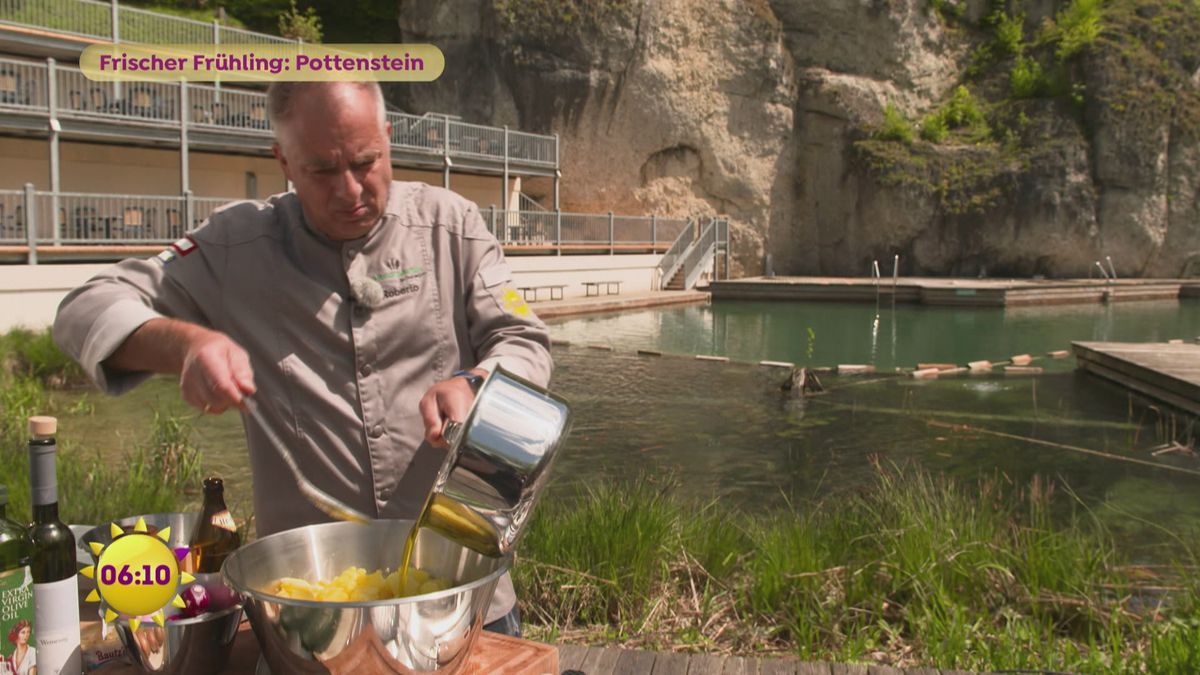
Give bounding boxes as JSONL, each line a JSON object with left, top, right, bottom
{"left": 96, "top": 622, "right": 558, "bottom": 675}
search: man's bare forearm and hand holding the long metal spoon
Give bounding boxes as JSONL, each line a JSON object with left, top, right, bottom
{"left": 104, "top": 318, "right": 254, "bottom": 414}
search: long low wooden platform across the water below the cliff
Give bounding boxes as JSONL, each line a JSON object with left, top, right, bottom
{"left": 709, "top": 276, "right": 1200, "bottom": 307}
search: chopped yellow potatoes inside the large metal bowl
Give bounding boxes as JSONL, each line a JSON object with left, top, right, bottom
{"left": 272, "top": 567, "right": 452, "bottom": 602}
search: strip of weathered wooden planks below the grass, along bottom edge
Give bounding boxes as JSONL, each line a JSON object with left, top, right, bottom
{"left": 558, "top": 645, "right": 966, "bottom": 675}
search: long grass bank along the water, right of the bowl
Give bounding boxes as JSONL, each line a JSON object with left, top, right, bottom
{"left": 514, "top": 458, "right": 1200, "bottom": 673}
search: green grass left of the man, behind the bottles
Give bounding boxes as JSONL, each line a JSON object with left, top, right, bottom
{"left": 0, "top": 329, "right": 200, "bottom": 524}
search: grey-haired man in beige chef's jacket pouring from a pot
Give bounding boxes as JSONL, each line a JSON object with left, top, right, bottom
{"left": 54, "top": 83, "right": 552, "bottom": 633}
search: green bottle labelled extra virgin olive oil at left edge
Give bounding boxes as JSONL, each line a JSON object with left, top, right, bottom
{"left": 0, "top": 485, "right": 35, "bottom": 673}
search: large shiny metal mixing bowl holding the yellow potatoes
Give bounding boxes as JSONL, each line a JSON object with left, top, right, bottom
{"left": 221, "top": 520, "right": 512, "bottom": 675}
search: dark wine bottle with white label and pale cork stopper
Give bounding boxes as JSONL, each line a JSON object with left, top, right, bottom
{"left": 29, "top": 417, "right": 83, "bottom": 675}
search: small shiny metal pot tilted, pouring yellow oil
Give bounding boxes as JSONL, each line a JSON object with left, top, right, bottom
{"left": 421, "top": 368, "right": 571, "bottom": 556}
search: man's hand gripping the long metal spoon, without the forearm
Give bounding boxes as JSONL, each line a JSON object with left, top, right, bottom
{"left": 179, "top": 330, "right": 254, "bottom": 414}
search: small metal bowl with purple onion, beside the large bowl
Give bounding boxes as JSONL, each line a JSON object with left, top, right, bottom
{"left": 116, "top": 605, "right": 241, "bottom": 675}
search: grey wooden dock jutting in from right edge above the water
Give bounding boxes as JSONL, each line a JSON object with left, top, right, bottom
{"left": 1070, "top": 342, "right": 1200, "bottom": 416}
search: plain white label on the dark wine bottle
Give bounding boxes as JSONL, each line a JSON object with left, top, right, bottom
{"left": 34, "top": 574, "right": 83, "bottom": 675}
